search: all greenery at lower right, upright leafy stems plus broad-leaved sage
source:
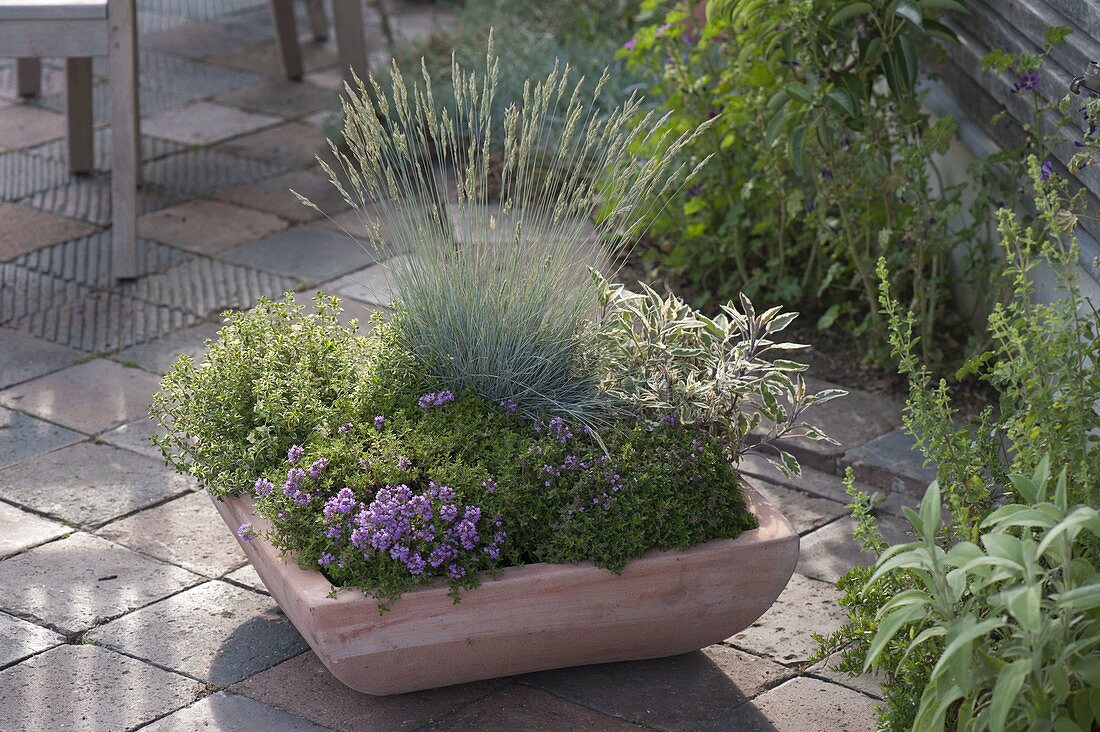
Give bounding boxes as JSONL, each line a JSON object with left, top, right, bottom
{"left": 821, "top": 156, "right": 1100, "bottom": 730}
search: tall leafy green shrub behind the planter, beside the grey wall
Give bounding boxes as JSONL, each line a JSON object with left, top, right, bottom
{"left": 624, "top": 0, "right": 974, "bottom": 362}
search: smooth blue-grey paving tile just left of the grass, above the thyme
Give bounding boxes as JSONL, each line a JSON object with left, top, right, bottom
{"left": 221, "top": 225, "right": 374, "bottom": 282}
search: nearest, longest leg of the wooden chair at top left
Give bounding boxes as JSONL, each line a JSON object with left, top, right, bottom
{"left": 107, "top": 0, "right": 141, "bottom": 280}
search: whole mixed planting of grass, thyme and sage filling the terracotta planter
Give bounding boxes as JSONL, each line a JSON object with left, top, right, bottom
{"left": 153, "top": 42, "right": 838, "bottom": 603}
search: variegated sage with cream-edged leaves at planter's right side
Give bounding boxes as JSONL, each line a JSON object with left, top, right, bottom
{"left": 594, "top": 274, "right": 846, "bottom": 476}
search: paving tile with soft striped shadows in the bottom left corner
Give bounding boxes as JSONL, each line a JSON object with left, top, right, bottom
{"left": 0, "top": 645, "right": 202, "bottom": 732}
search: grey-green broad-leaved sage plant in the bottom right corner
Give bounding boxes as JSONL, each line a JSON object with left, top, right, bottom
{"left": 864, "top": 457, "right": 1100, "bottom": 732}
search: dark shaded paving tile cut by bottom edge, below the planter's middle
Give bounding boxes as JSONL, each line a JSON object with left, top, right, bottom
{"left": 425, "top": 685, "right": 645, "bottom": 732}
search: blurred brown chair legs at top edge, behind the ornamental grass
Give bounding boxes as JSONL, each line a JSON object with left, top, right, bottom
{"left": 271, "top": 0, "right": 367, "bottom": 81}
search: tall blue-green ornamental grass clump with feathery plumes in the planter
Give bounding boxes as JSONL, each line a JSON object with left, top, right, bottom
{"left": 305, "top": 37, "right": 705, "bottom": 423}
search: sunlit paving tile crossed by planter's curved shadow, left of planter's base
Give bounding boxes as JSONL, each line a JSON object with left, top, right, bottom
{"left": 88, "top": 581, "right": 308, "bottom": 687}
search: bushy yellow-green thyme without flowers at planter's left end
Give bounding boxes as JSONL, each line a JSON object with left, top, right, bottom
{"left": 150, "top": 294, "right": 367, "bottom": 495}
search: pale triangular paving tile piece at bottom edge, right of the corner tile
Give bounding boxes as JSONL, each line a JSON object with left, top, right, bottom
{"left": 142, "top": 691, "right": 325, "bottom": 732}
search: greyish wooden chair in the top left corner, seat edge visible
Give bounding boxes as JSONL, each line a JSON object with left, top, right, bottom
{"left": 0, "top": 0, "right": 141, "bottom": 280}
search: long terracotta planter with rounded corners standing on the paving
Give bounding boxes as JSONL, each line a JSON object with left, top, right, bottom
{"left": 215, "top": 485, "right": 799, "bottom": 695}
